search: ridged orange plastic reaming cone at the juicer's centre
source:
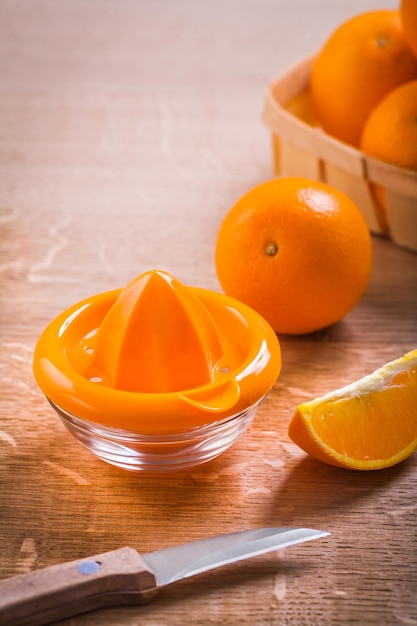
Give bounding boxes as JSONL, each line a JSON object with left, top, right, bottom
{"left": 93, "top": 271, "right": 223, "bottom": 393}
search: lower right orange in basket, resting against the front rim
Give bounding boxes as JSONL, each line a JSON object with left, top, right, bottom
{"left": 361, "top": 78, "right": 417, "bottom": 170}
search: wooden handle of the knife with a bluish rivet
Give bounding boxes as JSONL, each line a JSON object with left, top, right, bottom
{"left": 0, "top": 548, "right": 156, "bottom": 626}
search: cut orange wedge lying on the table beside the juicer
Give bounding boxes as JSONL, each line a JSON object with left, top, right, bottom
{"left": 288, "top": 349, "right": 417, "bottom": 470}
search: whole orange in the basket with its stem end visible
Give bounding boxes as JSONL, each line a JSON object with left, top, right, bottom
{"left": 310, "top": 9, "right": 417, "bottom": 146}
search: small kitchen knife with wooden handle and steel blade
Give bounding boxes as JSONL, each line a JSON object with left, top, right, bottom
{"left": 0, "top": 527, "right": 329, "bottom": 626}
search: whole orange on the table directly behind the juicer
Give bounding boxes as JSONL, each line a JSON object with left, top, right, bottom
{"left": 215, "top": 177, "right": 372, "bottom": 334}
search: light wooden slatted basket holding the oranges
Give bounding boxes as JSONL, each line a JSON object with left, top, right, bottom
{"left": 263, "top": 57, "right": 417, "bottom": 252}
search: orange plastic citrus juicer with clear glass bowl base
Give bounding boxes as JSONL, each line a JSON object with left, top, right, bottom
{"left": 34, "top": 270, "right": 281, "bottom": 470}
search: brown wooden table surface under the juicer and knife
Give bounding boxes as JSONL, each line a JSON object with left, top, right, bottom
{"left": 0, "top": 0, "right": 417, "bottom": 626}
